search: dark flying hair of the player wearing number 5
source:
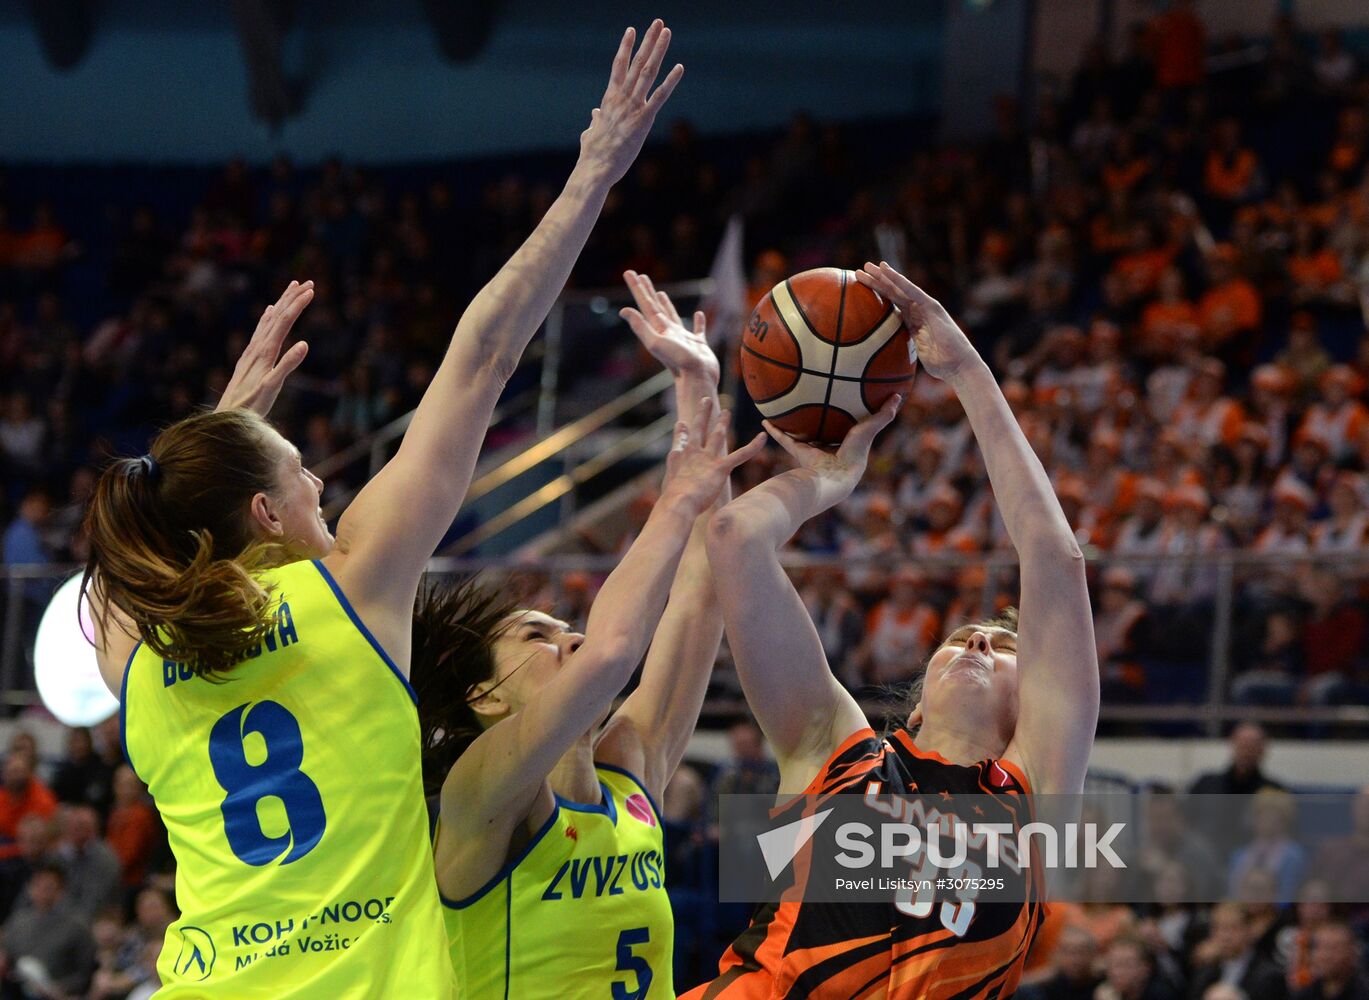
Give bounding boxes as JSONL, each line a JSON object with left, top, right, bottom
{"left": 409, "top": 577, "right": 520, "bottom": 795}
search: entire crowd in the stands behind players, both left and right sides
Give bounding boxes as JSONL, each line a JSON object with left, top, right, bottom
{"left": 0, "top": 3, "right": 1369, "bottom": 705}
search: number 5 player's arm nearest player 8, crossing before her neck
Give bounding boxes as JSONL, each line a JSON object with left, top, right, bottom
{"left": 437, "top": 404, "right": 763, "bottom": 895}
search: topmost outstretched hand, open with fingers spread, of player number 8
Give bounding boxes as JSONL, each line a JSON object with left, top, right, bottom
{"left": 580, "top": 19, "right": 685, "bottom": 184}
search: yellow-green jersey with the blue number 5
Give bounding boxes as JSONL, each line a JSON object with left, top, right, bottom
{"left": 442, "top": 764, "right": 675, "bottom": 1000}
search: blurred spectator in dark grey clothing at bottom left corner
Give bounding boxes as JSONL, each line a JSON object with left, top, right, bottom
{"left": 0, "top": 864, "right": 94, "bottom": 996}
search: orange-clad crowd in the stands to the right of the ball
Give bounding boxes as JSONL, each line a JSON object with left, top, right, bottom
{"left": 564, "top": 3, "right": 1369, "bottom": 705}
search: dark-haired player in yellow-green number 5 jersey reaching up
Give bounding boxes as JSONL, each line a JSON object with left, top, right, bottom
{"left": 413, "top": 271, "right": 764, "bottom": 1000}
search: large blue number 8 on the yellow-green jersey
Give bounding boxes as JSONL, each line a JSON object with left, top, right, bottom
{"left": 209, "top": 701, "right": 327, "bottom": 866}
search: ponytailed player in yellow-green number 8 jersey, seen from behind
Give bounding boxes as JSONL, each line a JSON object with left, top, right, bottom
{"left": 88, "top": 22, "right": 682, "bottom": 1000}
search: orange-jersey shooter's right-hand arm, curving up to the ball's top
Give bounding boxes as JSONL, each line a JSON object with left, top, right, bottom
{"left": 857, "top": 264, "right": 1098, "bottom": 793}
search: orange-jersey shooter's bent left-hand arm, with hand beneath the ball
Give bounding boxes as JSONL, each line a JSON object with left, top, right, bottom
{"left": 708, "top": 397, "right": 901, "bottom": 792}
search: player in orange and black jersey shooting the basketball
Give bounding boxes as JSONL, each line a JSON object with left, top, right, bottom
{"left": 686, "top": 258, "right": 1098, "bottom": 1000}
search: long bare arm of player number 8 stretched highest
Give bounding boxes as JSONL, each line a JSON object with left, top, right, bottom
{"left": 327, "top": 21, "right": 683, "bottom": 671}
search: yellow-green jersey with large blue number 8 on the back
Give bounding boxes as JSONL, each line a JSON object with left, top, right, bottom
{"left": 120, "top": 562, "right": 453, "bottom": 1000}
